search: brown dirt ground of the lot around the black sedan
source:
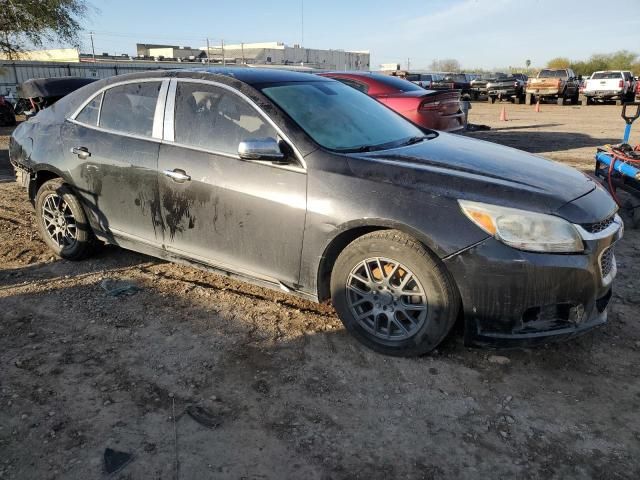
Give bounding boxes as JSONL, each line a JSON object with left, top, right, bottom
{"left": 0, "top": 103, "right": 640, "bottom": 479}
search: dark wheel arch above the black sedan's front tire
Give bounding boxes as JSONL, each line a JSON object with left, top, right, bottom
{"left": 316, "top": 219, "right": 446, "bottom": 302}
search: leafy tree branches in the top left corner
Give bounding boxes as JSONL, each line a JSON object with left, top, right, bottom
{"left": 0, "top": 0, "right": 89, "bottom": 58}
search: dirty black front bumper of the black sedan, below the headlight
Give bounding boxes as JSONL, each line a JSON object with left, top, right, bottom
{"left": 445, "top": 218, "right": 622, "bottom": 348}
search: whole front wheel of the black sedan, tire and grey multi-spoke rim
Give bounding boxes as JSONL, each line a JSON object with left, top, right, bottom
{"left": 331, "top": 230, "right": 460, "bottom": 356}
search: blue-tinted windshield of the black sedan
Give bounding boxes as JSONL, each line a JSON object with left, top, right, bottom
{"left": 262, "top": 80, "right": 425, "bottom": 152}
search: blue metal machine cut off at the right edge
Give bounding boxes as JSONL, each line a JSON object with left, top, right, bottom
{"left": 595, "top": 103, "right": 640, "bottom": 227}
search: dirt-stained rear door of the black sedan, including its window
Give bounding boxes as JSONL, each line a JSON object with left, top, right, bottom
{"left": 62, "top": 79, "right": 169, "bottom": 246}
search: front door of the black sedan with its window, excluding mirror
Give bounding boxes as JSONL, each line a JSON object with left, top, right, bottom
{"left": 158, "top": 79, "right": 307, "bottom": 285}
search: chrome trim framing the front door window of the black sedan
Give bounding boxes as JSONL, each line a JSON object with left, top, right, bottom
{"left": 164, "top": 78, "right": 307, "bottom": 172}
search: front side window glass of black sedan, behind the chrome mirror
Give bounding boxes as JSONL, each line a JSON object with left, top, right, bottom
{"left": 174, "top": 82, "right": 277, "bottom": 156}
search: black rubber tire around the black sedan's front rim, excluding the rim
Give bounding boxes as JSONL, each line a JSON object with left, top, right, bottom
{"left": 331, "top": 230, "right": 460, "bottom": 357}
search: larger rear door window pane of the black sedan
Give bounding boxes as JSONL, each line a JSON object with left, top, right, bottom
{"left": 100, "top": 82, "right": 161, "bottom": 137}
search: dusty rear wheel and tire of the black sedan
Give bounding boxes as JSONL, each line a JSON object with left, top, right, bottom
{"left": 35, "top": 178, "right": 95, "bottom": 260}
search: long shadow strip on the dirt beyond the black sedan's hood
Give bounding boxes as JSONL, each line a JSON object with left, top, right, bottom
{"left": 466, "top": 130, "right": 620, "bottom": 154}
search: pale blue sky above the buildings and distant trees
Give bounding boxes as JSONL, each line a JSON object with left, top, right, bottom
{"left": 60, "top": 0, "right": 640, "bottom": 70}
